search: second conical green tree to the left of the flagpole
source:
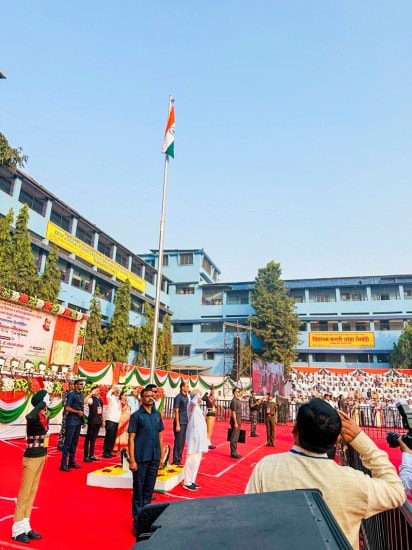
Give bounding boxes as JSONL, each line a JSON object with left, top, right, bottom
{"left": 103, "top": 279, "right": 133, "bottom": 363}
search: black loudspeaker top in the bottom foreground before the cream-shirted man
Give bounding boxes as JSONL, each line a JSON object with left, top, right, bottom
{"left": 132, "top": 490, "right": 351, "bottom": 550}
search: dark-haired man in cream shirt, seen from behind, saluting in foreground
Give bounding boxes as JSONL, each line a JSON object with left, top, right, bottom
{"left": 245, "top": 399, "right": 405, "bottom": 549}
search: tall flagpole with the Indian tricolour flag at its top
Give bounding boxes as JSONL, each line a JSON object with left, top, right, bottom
{"left": 150, "top": 96, "right": 175, "bottom": 384}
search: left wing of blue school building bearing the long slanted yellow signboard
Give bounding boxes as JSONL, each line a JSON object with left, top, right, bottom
{"left": 0, "top": 168, "right": 170, "bottom": 361}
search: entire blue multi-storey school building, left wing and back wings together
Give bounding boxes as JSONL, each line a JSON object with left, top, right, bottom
{"left": 0, "top": 169, "right": 412, "bottom": 376}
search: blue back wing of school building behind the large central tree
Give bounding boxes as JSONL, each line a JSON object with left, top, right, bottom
{"left": 142, "top": 250, "right": 412, "bottom": 374}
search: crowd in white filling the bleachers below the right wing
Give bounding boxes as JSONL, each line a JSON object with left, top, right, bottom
{"left": 289, "top": 371, "right": 412, "bottom": 428}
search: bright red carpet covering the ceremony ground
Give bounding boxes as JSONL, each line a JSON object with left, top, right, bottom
{"left": 0, "top": 420, "right": 401, "bottom": 550}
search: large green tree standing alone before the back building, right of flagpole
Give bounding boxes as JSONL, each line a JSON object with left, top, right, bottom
{"left": 249, "top": 261, "right": 300, "bottom": 375}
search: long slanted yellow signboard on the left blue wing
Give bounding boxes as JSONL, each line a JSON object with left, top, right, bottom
{"left": 46, "top": 222, "right": 146, "bottom": 292}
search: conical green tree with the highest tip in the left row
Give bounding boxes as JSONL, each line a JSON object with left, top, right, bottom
{"left": 3, "top": 204, "right": 40, "bottom": 296}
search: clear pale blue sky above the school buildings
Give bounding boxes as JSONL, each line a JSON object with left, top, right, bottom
{"left": 0, "top": 0, "right": 412, "bottom": 281}
